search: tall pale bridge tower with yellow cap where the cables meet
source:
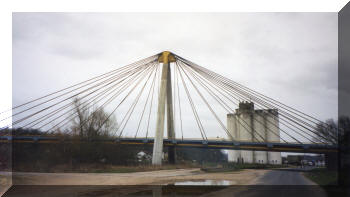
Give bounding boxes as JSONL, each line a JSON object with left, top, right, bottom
{"left": 152, "top": 51, "right": 176, "bottom": 165}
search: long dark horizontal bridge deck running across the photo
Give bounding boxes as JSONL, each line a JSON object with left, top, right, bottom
{"left": 0, "top": 136, "right": 338, "bottom": 153}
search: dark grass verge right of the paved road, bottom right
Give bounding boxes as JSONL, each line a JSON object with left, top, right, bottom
{"left": 304, "top": 168, "right": 338, "bottom": 186}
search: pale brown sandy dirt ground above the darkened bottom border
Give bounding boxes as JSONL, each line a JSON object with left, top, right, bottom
{"left": 13, "top": 168, "right": 269, "bottom": 185}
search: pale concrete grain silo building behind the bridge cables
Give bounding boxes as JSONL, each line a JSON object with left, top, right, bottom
{"left": 227, "top": 102, "right": 282, "bottom": 164}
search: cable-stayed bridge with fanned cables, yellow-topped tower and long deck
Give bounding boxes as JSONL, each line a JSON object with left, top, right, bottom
{"left": 0, "top": 51, "right": 337, "bottom": 165}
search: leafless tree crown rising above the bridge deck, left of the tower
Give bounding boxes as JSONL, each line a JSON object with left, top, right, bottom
{"left": 71, "top": 98, "right": 118, "bottom": 140}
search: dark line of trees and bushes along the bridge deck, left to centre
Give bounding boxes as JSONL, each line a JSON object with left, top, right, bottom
{"left": 0, "top": 99, "right": 226, "bottom": 172}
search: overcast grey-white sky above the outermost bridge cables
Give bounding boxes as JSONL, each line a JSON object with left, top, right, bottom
{"left": 13, "top": 13, "right": 338, "bottom": 140}
